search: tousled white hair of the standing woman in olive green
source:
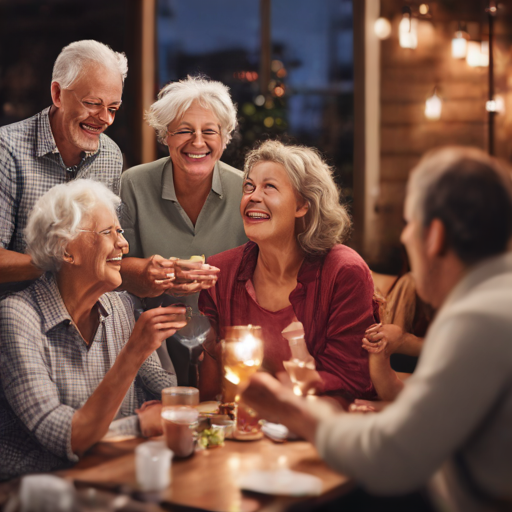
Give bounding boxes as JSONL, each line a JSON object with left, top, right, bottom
{"left": 145, "top": 75, "right": 237, "bottom": 146}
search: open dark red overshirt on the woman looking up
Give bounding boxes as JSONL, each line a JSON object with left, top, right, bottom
{"left": 199, "top": 242, "right": 378, "bottom": 398}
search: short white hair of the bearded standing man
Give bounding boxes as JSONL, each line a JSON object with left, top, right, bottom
{"left": 52, "top": 39, "right": 128, "bottom": 89}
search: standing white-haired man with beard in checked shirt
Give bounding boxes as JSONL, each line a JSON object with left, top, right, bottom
{"left": 0, "top": 40, "right": 128, "bottom": 295}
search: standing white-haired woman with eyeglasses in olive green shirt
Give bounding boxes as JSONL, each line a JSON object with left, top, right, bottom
{"left": 121, "top": 76, "right": 247, "bottom": 367}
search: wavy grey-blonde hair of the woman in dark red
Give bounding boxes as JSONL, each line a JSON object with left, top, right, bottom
{"left": 244, "top": 140, "right": 352, "bottom": 254}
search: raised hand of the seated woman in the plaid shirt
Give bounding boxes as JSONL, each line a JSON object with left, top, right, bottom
{"left": 126, "top": 305, "right": 187, "bottom": 364}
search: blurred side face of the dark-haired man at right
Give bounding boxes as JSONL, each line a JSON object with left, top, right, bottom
{"left": 400, "top": 193, "right": 432, "bottom": 303}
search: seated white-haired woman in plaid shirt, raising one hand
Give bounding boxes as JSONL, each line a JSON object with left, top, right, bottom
{"left": 0, "top": 180, "right": 185, "bottom": 479}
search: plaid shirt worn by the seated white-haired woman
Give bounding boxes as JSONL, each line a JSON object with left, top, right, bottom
{"left": 0, "top": 273, "right": 176, "bottom": 479}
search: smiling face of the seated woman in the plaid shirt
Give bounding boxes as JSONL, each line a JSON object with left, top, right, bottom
{"left": 66, "top": 206, "right": 128, "bottom": 291}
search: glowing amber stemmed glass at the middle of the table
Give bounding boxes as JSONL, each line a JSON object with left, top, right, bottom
{"left": 222, "top": 325, "right": 263, "bottom": 439}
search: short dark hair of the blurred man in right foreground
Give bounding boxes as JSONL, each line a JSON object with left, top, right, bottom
{"left": 408, "top": 147, "right": 512, "bottom": 265}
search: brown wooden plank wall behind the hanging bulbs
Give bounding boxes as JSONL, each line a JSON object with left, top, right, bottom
{"left": 365, "top": 0, "right": 512, "bottom": 273}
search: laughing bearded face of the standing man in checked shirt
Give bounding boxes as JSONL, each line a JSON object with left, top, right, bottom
{"left": 52, "top": 65, "right": 123, "bottom": 151}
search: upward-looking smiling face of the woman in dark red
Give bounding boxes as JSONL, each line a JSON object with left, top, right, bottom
{"left": 240, "top": 162, "right": 308, "bottom": 243}
